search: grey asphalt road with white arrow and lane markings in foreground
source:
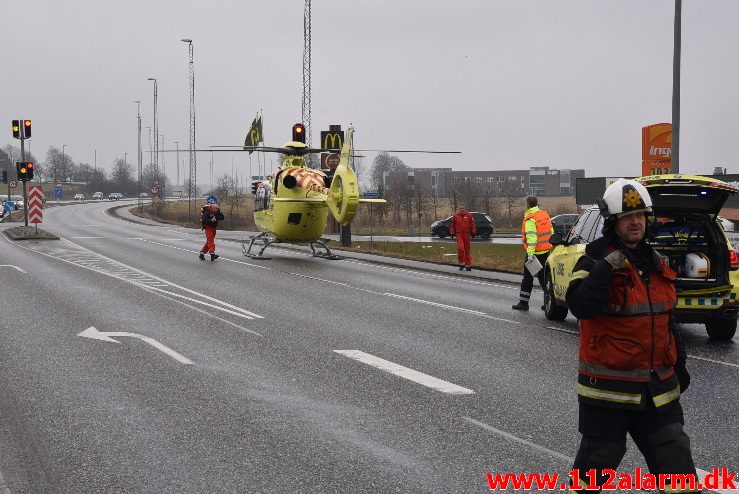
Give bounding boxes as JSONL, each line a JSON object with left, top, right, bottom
{"left": 0, "top": 203, "right": 739, "bottom": 494}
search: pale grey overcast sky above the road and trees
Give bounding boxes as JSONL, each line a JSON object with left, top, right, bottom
{"left": 0, "top": 0, "right": 739, "bottom": 183}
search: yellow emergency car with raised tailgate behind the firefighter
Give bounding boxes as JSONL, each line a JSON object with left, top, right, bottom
{"left": 544, "top": 175, "right": 739, "bottom": 340}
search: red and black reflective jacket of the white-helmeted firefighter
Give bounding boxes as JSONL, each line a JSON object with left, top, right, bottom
{"left": 566, "top": 237, "right": 686, "bottom": 409}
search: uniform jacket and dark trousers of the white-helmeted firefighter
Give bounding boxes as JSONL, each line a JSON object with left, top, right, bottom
{"left": 566, "top": 236, "right": 700, "bottom": 492}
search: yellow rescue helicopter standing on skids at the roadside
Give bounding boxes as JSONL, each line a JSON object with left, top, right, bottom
{"left": 242, "top": 124, "right": 385, "bottom": 259}
